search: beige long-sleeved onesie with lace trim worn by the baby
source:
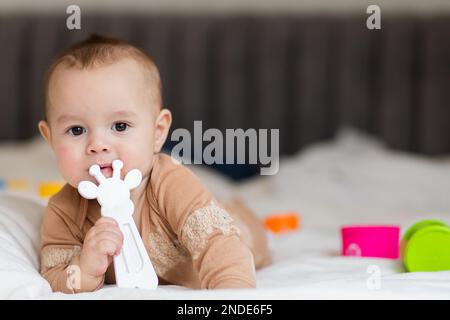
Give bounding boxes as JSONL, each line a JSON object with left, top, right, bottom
{"left": 41, "top": 154, "right": 270, "bottom": 293}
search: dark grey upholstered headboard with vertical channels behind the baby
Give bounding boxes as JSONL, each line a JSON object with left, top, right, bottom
{"left": 0, "top": 15, "right": 450, "bottom": 154}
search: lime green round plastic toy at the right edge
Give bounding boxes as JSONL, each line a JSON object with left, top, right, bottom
{"left": 400, "top": 220, "right": 450, "bottom": 272}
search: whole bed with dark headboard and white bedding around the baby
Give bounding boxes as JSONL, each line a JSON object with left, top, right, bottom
{"left": 0, "top": 13, "right": 450, "bottom": 300}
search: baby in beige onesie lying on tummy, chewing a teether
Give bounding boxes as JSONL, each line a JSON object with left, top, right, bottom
{"left": 39, "top": 35, "right": 270, "bottom": 293}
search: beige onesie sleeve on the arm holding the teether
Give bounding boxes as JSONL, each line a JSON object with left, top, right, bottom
{"left": 40, "top": 186, "right": 103, "bottom": 293}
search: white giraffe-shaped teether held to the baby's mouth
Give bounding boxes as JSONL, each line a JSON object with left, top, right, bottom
{"left": 78, "top": 160, "right": 158, "bottom": 289}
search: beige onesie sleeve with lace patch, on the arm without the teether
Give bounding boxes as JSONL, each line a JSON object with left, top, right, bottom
{"left": 152, "top": 155, "right": 256, "bottom": 289}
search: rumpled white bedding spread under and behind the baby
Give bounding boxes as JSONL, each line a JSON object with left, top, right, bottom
{"left": 0, "top": 130, "right": 450, "bottom": 300}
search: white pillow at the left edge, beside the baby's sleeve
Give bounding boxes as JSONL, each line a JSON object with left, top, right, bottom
{"left": 0, "top": 193, "right": 52, "bottom": 299}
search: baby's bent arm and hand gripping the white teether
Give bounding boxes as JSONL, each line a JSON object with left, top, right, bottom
{"left": 41, "top": 204, "right": 123, "bottom": 293}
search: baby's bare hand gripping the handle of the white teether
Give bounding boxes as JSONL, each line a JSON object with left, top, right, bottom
{"left": 80, "top": 217, "right": 123, "bottom": 278}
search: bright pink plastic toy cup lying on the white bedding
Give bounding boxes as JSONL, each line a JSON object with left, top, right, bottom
{"left": 341, "top": 225, "right": 400, "bottom": 259}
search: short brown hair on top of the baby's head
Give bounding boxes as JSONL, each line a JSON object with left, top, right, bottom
{"left": 44, "top": 34, "right": 162, "bottom": 120}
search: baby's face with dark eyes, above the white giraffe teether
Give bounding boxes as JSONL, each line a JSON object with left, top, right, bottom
{"left": 40, "top": 59, "right": 164, "bottom": 187}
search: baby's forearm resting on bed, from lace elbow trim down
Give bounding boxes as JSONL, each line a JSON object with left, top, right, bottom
{"left": 181, "top": 202, "right": 256, "bottom": 289}
